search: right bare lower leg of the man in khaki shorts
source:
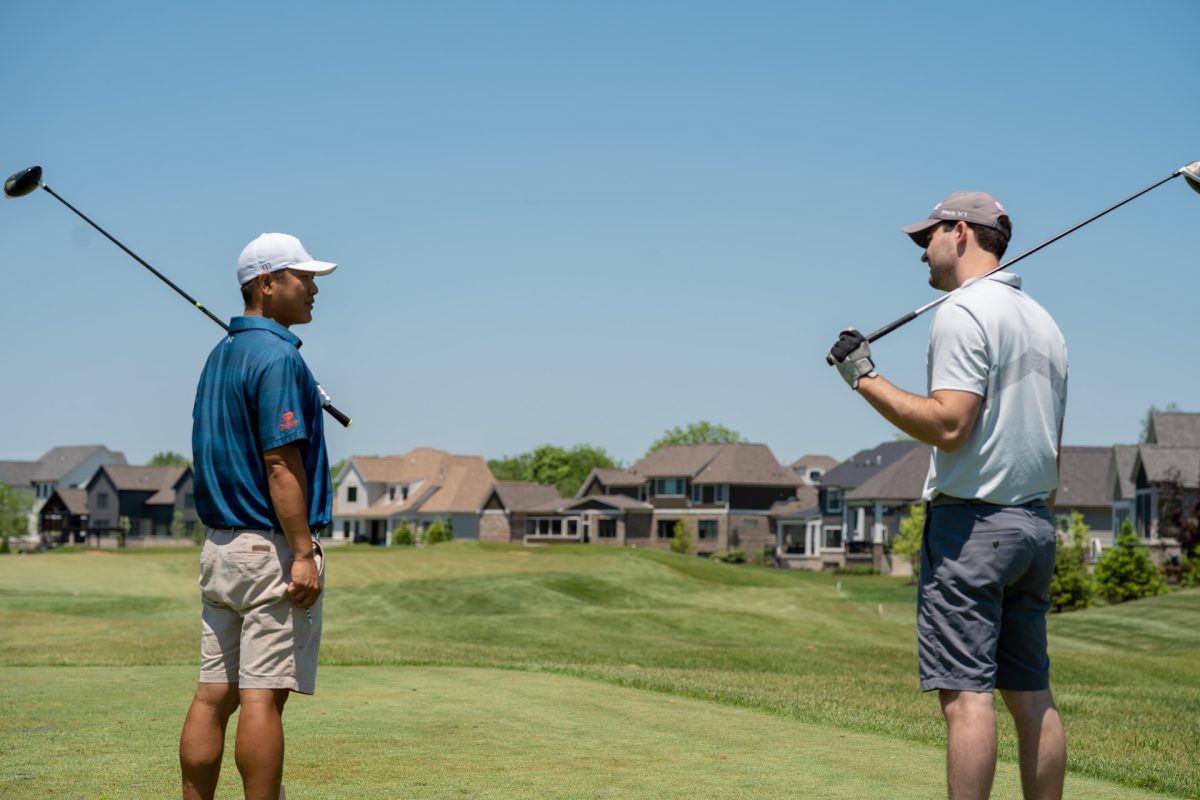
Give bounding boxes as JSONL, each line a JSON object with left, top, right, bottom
{"left": 234, "top": 688, "right": 288, "bottom": 800}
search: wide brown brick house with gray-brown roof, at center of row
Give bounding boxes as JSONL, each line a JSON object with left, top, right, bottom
{"left": 511, "top": 444, "right": 803, "bottom": 555}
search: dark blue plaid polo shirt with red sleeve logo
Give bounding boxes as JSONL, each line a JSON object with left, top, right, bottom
{"left": 192, "top": 317, "right": 334, "bottom": 533}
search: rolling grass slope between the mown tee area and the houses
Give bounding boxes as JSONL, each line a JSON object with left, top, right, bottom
{"left": 0, "top": 542, "right": 1200, "bottom": 796}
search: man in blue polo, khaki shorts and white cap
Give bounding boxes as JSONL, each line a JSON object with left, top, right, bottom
{"left": 179, "top": 234, "right": 337, "bottom": 800}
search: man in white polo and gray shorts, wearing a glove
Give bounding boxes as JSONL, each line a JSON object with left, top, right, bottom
{"left": 830, "top": 192, "right": 1067, "bottom": 800}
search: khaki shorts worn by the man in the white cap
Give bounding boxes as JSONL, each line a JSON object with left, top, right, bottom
{"left": 200, "top": 529, "right": 325, "bottom": 694}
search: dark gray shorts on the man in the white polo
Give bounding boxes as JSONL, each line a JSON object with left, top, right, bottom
{"left": 917, "top": 504, "right": 1057, "bottom": 692}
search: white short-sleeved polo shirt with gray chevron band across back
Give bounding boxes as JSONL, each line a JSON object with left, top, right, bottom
{"left": 924, "top": 272, "right": 1067, "bottom": 505}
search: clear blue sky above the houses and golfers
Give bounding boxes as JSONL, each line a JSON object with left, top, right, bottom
{"left": 0, "top": 0, "right": 1200, "bottom": 463}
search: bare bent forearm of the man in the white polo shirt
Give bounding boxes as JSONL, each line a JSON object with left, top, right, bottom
{"left": 858, "top": 375, "right": 983, "bottom": 452}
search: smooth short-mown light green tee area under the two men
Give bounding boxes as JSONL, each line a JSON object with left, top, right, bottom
{"left": 0, "top": 667, "right": 1166, "bottom": 800}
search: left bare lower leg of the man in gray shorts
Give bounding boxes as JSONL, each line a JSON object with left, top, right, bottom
{"left": 938, "top": 690, "right": 996, "bottom": 800}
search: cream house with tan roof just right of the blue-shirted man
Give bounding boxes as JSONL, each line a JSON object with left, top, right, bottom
{"left": 331, "top": 447, "right": 496, "bottom": 545}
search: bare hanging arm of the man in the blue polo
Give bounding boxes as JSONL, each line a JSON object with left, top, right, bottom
{"left": 263, "top": 443, "right": 320, "bottom": 608}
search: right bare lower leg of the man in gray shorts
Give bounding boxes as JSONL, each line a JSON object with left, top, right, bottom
{"left": 1001, "top": 690, "right": 1067, "bottom": 800}
